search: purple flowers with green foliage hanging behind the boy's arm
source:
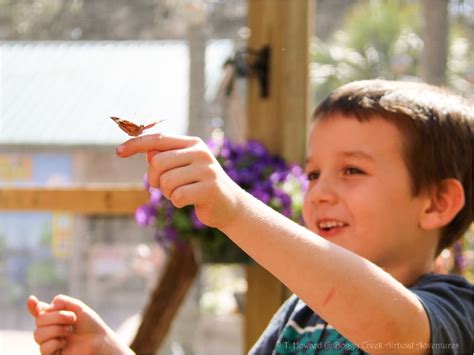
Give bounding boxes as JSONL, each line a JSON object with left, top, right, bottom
{"left": 135, "top": 135, "right": 306, "bottom": 259}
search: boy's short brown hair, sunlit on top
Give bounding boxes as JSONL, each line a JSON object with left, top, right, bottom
{"left": 313, "top": 80, "right": 474, "bottom": 254}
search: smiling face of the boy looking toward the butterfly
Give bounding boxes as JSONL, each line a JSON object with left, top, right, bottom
{"left": 303, "top": 115, "right": 426, "bottom": 268}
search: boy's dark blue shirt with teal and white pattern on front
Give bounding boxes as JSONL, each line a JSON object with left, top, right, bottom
{"left": 250, "top": 274, "right": 474, "bottom": 355}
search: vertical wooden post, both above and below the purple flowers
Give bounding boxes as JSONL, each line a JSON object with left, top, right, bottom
{"left": 245, "top": 0, "right": 313, "bottom": 351}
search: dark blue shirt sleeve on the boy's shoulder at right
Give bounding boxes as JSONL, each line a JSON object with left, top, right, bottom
{"left": 411, "top": 274, "right": 474, "bottom": 355}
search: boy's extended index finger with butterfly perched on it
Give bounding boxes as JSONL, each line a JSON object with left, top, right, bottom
{"left": 116, "top": 133, "right": 196, "bottom": 158}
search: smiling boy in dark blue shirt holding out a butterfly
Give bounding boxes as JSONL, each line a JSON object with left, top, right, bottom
{"left": 28, "top": 80, "right": 474, "bottom": 354}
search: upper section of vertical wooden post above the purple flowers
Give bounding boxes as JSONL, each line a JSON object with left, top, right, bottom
{"left": 247, "top": 0, "right": 313, "bottom": 163}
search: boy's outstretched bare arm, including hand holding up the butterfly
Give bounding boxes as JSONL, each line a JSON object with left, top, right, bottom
{"left": 117, "top": 134, "right": 430, "bottom": 353}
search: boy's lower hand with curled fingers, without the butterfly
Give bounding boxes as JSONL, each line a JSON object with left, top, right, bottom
{"left": 27, "top": 295, "right": 131, "bottom": 355}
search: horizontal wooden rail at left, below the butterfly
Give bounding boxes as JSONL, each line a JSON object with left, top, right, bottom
{"left": 0, "top": 185, "right": 148, "bottom": 215}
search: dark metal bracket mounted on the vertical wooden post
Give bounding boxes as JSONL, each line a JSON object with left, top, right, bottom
{"left": 230, "top": 45, "right": 270, "bottom": 98}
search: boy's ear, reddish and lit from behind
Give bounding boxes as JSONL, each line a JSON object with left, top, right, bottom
{"left": 420, "top": 179, "right": 465, "bottom": 230}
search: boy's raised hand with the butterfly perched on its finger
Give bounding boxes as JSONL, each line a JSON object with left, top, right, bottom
{"left": 117, "top": 134, "right": 243, "bottom": 229}
